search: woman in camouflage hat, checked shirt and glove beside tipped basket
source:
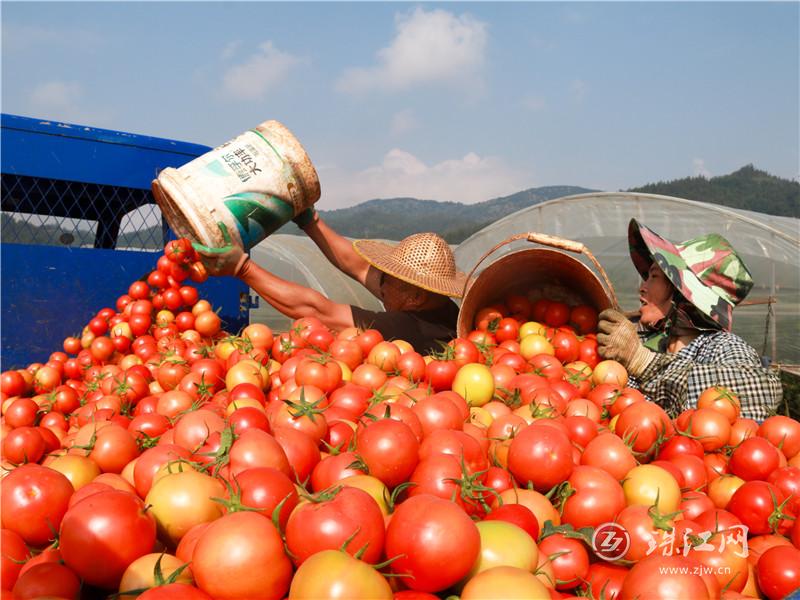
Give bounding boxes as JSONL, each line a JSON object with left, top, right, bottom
{"left": 597, "top": 219, "right": 782, "bottom": 421}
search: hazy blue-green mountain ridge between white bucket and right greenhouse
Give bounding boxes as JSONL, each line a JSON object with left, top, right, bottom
{"left": 290, "top": 185, "right": 594, "bottom": 244}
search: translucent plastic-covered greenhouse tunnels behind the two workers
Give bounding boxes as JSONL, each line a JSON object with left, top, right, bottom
{"left": 250, "top": 192, "right": 800, "bottom": 372}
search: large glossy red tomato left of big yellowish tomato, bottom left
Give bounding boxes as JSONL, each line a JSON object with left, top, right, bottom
{"left": 59, "top": 490, "right": 156, "bottom": 589}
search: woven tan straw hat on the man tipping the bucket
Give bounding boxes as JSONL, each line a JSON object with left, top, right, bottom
{"left": 353, "top": 233, "right": 467, "bottom": 298}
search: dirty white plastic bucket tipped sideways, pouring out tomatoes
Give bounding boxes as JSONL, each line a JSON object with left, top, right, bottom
{"left": 152, "top": 121, "right": 320, "bottom": 250}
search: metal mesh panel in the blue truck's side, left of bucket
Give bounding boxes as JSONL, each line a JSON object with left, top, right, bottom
{"left": 0, "top": 174, "right": 168, "bottom": 250}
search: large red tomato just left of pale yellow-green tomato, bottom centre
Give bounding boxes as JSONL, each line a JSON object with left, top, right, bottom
{"left": 386, "top": 495, "right": 480, "bottom": 592}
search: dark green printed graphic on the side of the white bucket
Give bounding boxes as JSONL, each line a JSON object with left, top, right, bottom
{"left": 222, "top": 192, "right": 294, "bottom": 250}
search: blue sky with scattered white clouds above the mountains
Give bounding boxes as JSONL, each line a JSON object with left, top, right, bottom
{"left": 2, "top": 2, "right": 800, "bottom": 209}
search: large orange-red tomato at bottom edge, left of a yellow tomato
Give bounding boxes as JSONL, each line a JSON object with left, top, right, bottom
{"left": 192, "top": 511, "right": 292, "bottom": 600}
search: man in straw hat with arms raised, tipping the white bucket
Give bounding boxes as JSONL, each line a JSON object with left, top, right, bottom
{"left": 195, "top": 209, "right": 466, "bottom": 354}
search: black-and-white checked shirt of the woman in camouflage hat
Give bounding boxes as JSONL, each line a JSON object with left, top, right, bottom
{"left": 633, "top": 332, "right": 783, "bottom": 422}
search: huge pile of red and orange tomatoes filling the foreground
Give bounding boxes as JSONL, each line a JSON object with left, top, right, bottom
{"left": 0, "top": 240, "right": 800, "bottom": 600}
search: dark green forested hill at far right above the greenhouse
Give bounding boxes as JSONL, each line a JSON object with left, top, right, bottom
{"left": 627, "top": 165, "right": 800, "bottom": 218}
